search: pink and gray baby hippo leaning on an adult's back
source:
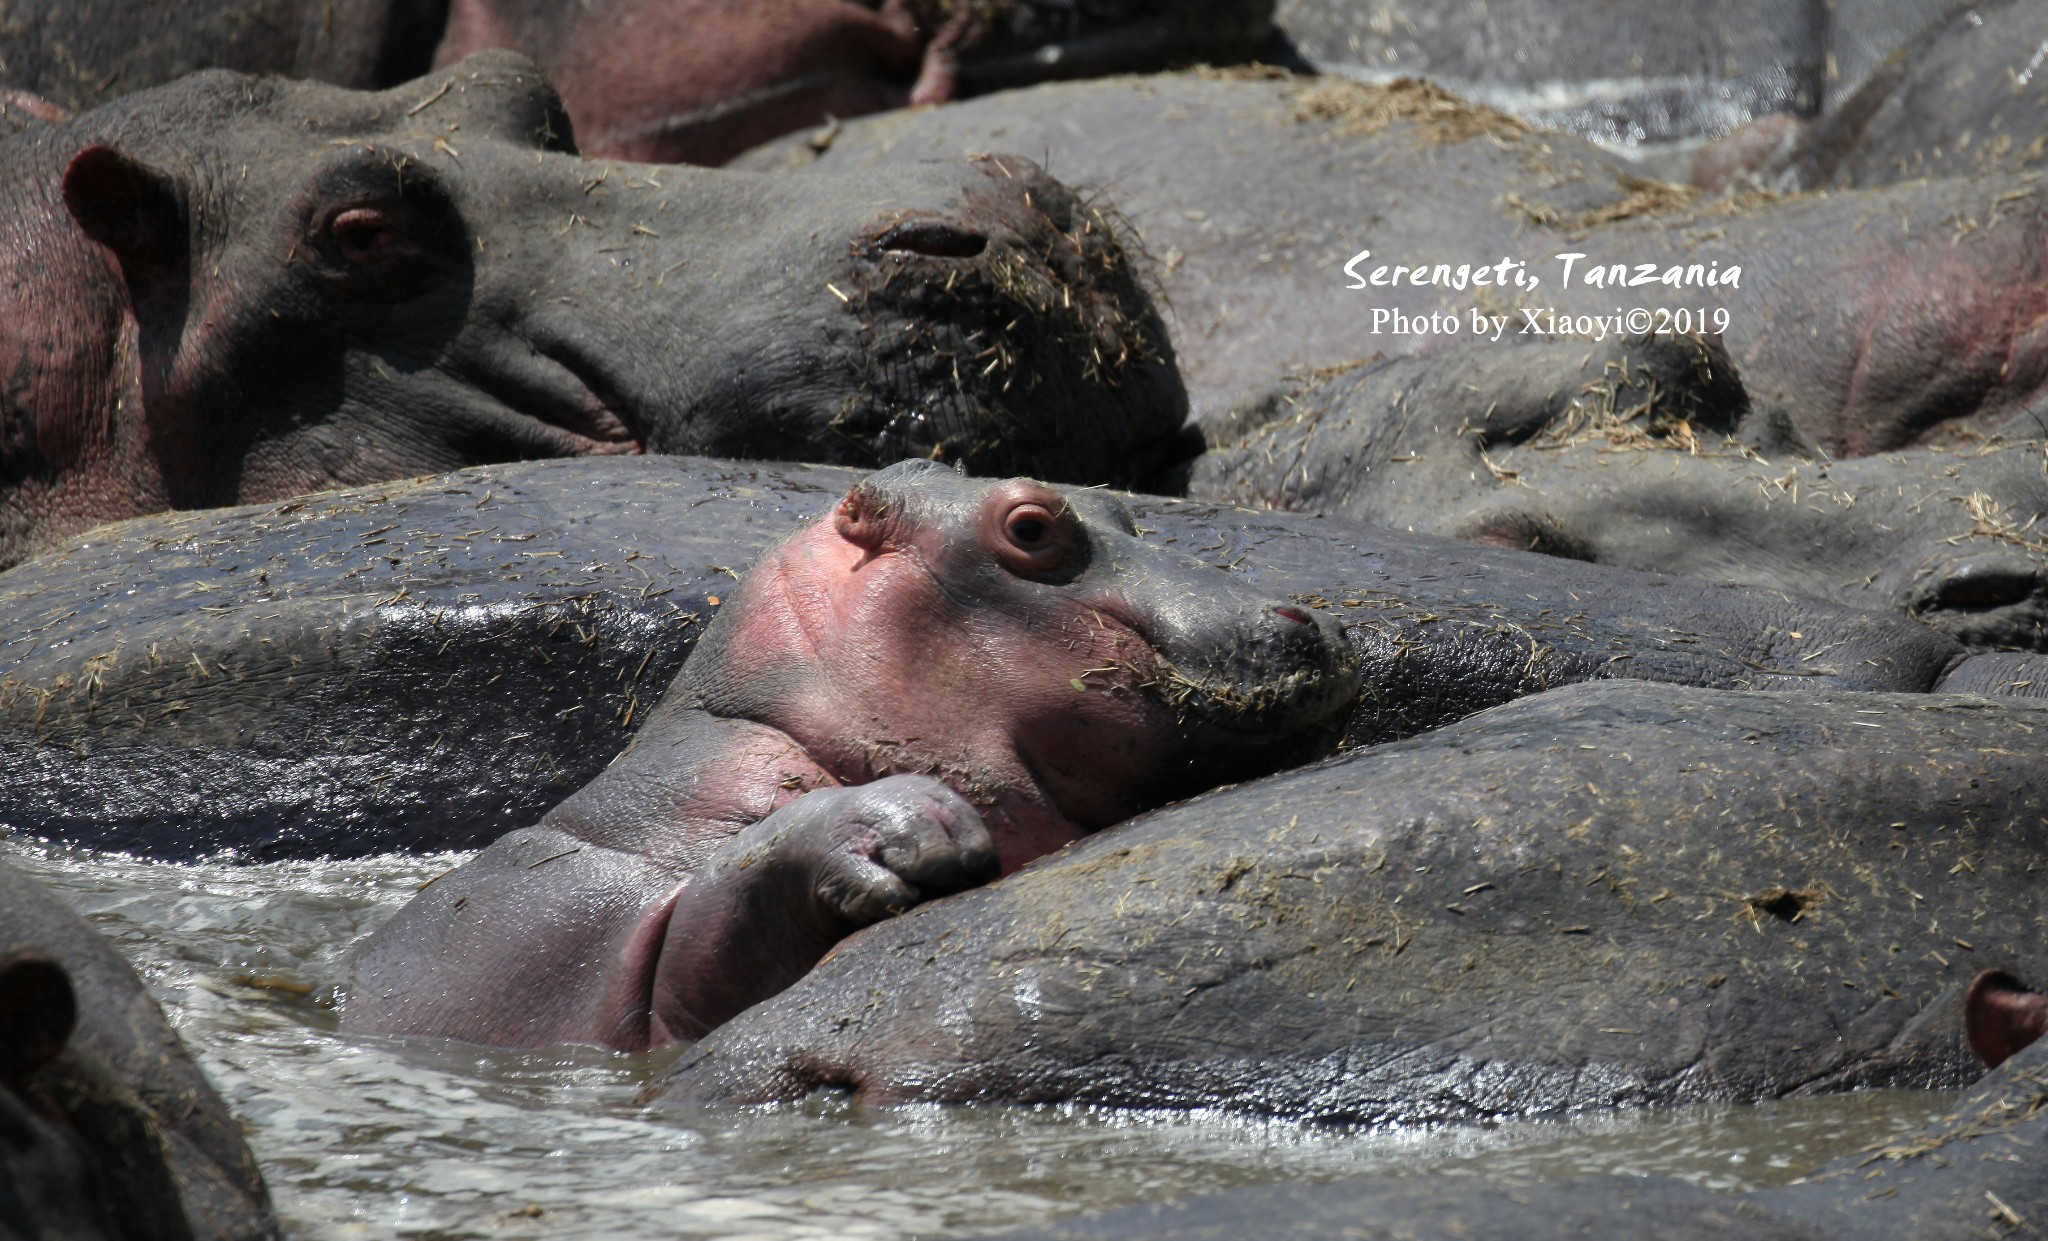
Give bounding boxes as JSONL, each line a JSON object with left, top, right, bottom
{"left": 342, "top": 461, "right": 1360, "bottom": 1051}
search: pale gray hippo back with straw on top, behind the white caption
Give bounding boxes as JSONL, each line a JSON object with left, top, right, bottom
{"left": 739, "top": 76, "right": 2048, "bottom": 457}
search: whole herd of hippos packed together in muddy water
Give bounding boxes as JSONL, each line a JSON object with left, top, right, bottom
{"left": 0, "top": 0, "right": 2048, "bottom": 1241}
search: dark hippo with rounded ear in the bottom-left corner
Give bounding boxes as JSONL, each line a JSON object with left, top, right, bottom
{"left": 0, "top": 858, "right": 276, "bottom": 1241}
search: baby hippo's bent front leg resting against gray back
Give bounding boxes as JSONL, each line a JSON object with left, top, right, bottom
{"left": 651, "top": 776, "right": 997, "bottom": 1044}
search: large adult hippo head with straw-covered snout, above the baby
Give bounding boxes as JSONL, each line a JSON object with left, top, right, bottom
{"left": 0, "top": 53, "right": 1186, "bottom": 563}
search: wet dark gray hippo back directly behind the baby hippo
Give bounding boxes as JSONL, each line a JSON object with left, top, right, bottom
{"left": 0, "top": 457, "right": 1966, "bottom": 858}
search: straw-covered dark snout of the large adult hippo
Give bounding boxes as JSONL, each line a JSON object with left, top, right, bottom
{"left": 823, "top": 156, "right": 1188, "bottom": 483}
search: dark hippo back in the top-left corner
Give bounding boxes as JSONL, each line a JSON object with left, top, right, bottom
{"left": 0, "top": 0, "right": 449, "bottom": 113}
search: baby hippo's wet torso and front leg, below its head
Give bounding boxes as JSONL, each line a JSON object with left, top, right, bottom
{"left": 344, "top": 776, "right": 997, "bottom": 1051}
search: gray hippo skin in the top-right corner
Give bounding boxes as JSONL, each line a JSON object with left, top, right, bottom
{"left": 1694, "top": 0, "right": 2048, "bottom": 190}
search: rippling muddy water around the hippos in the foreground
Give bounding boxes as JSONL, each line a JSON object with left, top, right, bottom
{"left": 0, "top": 840, "right": 1954, "bottom": 1239}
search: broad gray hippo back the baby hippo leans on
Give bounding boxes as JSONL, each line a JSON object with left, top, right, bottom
{"left": 653, "top": 682, "right": 2048, "bottom": 1124}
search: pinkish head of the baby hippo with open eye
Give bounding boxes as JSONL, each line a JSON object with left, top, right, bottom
{"left": 684, "top": 461, "right": 1360, "bottom": 870}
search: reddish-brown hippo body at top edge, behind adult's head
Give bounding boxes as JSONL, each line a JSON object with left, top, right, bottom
{"left": 436, "top": 0, "right": 1272, "bottom": 164}
